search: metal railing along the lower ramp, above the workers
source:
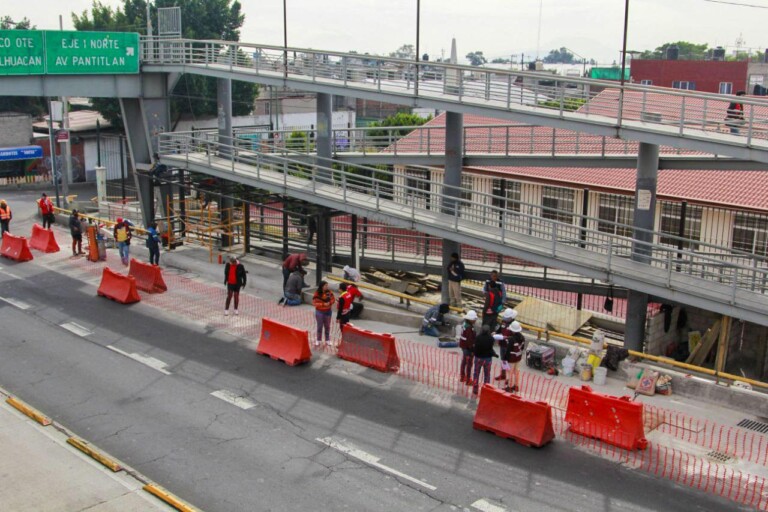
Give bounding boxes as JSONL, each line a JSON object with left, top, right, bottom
{"left": 159, "top": 133, "right": 768, "bottom": 310}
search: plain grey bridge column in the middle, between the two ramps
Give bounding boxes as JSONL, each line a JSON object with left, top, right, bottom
{"left": 440, "top": 112, "right": 464, "bottom": 302}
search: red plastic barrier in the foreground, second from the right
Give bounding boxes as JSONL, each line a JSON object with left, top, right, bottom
{"left": 472, "top": 384, "right": 555, "bottom": 448}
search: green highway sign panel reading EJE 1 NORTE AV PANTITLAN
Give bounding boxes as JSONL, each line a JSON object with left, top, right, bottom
{"left": 45, "top": 30, "right": 139, "bottom": 75}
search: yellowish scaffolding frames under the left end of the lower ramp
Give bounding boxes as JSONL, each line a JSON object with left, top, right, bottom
{"left": 167, "top": 196, "right": 246, "bottom": 263}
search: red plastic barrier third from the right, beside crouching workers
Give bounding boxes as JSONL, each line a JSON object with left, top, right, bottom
{"left": 337, "top": 324, "right": 400, "bottom": 372}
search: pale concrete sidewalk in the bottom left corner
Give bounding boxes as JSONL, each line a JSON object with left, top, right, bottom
{"left": 0, "top": 391, "right": 175, "bottom": 512}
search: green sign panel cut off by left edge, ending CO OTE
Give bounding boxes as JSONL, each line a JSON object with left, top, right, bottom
{"left": 0, "top": 30, "right": 45, "bottom": 75}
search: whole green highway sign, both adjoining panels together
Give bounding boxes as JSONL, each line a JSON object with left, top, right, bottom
{"left": 0, "top": 30, "right": 139, "bottom": 76}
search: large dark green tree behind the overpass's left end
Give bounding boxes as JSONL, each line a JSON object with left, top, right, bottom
{"left": 72, "top": 0, "right": 258, "bottom": 125}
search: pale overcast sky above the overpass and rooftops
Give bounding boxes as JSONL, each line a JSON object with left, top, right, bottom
{"left": 6, "top": 0, "right": 768, "bottom": 64}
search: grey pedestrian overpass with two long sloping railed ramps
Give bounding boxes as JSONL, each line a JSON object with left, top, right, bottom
{"left": 0, "top": 34, "right": 768, "bottom": 325}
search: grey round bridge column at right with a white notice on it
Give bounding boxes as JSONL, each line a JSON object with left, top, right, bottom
{"left": 624, "top": 142, "right": 659, "bottom": 352}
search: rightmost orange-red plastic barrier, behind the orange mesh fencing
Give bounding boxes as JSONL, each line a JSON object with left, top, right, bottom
{"left": 565, "top": 386, "right": 648, "bottom": 450}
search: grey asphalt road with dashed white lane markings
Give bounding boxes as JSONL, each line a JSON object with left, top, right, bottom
{"left": 0, "top": 189, "right": 746, "bottom": 512}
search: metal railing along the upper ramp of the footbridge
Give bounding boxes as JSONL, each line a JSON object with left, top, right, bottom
{"left": 141, "top": 38, "right": 768, "bottom": 149}
